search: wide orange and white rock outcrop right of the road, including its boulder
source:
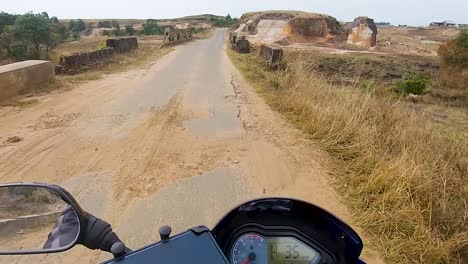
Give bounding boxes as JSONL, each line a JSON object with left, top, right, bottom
{"left": 235, "top": 11, "right": 377, "bottom": 48}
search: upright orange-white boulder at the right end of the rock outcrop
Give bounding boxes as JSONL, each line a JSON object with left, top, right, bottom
{"left": 347, "top": 17, "right": 377, "bottom": 48}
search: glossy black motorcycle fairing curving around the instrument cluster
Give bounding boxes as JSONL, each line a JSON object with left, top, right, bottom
{"left": 212, "top": 198, "right": 363, "bottom": 263}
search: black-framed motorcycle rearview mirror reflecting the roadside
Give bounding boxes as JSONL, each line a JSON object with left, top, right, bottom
{"left": 0, "top": 184, "right": 81, "bottom": 255}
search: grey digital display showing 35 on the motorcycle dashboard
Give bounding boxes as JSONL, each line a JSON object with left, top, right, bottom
{"left": 267, "top": 237, "right": 320, "bottom": 264}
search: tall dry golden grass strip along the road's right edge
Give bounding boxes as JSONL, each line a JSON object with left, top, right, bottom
{"left": 229, "top": 51, "right": 468, "bottom": 263}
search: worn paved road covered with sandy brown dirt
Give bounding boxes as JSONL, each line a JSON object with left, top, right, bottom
{"left": 0, "top": 30, "right": 380, "bottom": 263}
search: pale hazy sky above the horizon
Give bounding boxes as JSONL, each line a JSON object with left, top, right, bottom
{"left": 0, "top": 0, "right": 468, "bottom": 25}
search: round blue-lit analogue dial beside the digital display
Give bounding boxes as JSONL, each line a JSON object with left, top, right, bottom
{"left": 231, "top": 234, "right": 268, "bottom": 264}
